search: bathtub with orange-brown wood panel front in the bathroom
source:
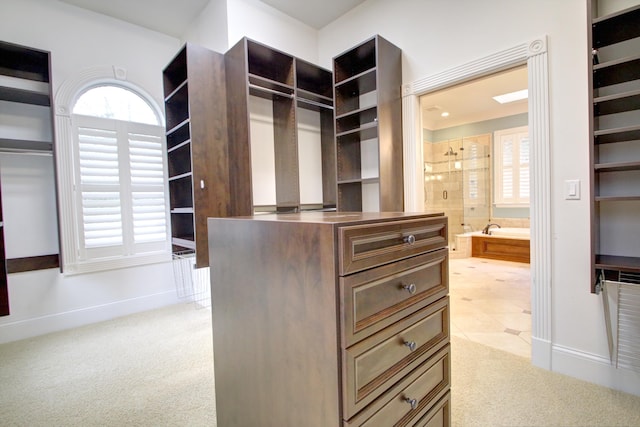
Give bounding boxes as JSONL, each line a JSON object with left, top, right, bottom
{"left": 451, "top": 227, "right": 531, "bottom": 263}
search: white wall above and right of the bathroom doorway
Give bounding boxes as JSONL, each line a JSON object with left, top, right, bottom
{"left": 318, "top": 0, "right": 640, "bottom": 394}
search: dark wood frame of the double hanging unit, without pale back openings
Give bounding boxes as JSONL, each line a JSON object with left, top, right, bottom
{"left": 225, "top": 38, "right": 335, "bottom": 215}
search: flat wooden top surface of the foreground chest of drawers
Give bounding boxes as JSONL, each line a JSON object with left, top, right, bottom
{"left": 210, "top": 212, "right": 444, "bottom": 225}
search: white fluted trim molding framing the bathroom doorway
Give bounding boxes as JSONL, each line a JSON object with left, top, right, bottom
{"left": 402, "top": 36, "right": 552, "bottom": 370}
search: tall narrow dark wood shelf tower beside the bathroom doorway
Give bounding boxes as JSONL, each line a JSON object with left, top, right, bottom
{"left": 333, "top": 35, "right": 404, "bottom": 211}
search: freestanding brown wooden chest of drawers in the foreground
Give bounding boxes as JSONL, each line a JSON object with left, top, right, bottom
{"left": 208, "top": 212, "right": 451, "bottom": 427}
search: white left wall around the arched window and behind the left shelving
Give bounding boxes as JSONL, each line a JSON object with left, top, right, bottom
{"left": 0, "top": 0, "right": 180, "bottom": 342}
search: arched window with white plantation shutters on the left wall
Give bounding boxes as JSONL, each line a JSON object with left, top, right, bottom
{"left": 56, "top": 83, "right": 170, "bottom": 272}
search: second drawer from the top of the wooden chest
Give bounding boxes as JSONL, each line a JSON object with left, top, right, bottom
{"left": 340, "top": 248, "right": 449, "bottom": 347}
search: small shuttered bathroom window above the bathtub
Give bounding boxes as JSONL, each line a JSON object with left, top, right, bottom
{"left": 493, "top": 126, "right": 530, "bottom": 207}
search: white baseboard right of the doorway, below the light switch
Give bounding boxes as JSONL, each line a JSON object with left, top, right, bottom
{"left": 552, "top": 345, "right": 640, "bottom": 396}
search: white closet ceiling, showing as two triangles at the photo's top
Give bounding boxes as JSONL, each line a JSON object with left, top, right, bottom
{"left": 60, "top": 0, "right": 365, "bottom": 38}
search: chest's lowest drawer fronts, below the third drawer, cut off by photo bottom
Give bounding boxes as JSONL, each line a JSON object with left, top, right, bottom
{"left": 344, "top": 345, "right": 451, "bottom": 427}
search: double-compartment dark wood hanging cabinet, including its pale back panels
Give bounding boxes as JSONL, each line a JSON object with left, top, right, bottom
{"left": 225, "top": 38, "right": 335, "bottom": 215}
